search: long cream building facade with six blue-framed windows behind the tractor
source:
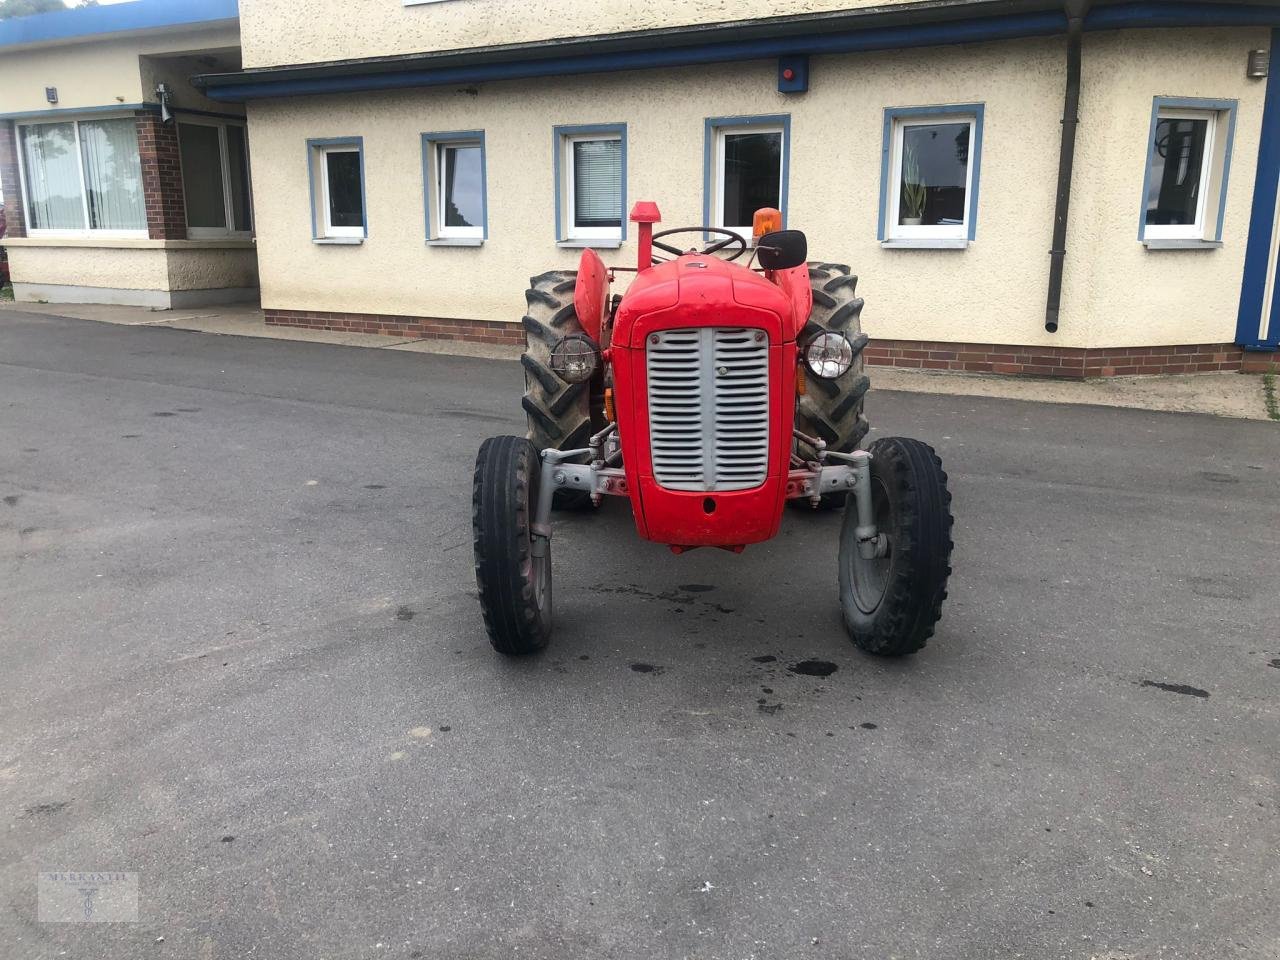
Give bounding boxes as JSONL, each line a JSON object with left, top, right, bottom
{"left": 0, "top": 0, "right": 1280, "bottom": 376}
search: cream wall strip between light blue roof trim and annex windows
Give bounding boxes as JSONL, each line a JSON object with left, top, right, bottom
{"left": 0, "top": 27, "right": 239, "bottom": 114}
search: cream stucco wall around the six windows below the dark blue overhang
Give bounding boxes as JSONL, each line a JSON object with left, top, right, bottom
{"left": 240, "top": 29, "right": 1266, "bottom": 347}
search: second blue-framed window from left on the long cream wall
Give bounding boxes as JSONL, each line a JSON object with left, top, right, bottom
{"left": 422, "top": 131, "right": 488, "bottom": 246}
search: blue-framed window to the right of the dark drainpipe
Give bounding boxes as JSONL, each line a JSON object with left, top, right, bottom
{"left": 1138, "top": 97, "right": 1235, "bottom": 246}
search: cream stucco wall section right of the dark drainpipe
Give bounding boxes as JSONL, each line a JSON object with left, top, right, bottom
{"left": 1064, "top": 28, "right": 1270, "bottom": 346}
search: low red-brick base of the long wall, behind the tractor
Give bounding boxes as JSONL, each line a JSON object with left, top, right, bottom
{"left": 265, "top": 310, "right": 1280, "bottom": 380}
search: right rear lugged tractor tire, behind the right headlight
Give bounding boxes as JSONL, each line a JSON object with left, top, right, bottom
{"left": 795, "top": 262, "right": 870, "bottom": 460}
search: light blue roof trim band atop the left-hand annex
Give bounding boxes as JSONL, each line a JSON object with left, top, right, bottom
{"left": 0, "top": 0, "right": 239, "bottom": 47}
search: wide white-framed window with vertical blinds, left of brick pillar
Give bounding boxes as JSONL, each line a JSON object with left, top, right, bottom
{"left": 18, "top": 116, "right": 147, "bottom": 237}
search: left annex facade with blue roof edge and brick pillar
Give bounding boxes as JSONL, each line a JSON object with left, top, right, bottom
{"left": 0, "top": 0, "right": 257, "bottom": 308}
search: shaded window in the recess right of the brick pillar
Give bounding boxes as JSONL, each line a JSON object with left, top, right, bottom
{"left": 178, "top": 120, "right": 253, "bottom": 239}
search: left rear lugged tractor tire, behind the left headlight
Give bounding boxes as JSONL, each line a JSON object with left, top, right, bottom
{"left": 520, "top": 270, "right": 593, "bottom": 507}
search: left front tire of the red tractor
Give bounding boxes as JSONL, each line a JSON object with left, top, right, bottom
{"left": 471, "top": 436, "right": 552, "bottom": 655}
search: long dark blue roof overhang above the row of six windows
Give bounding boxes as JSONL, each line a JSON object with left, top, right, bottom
{"left": 192, "top": 0, "right": 1280, "bottom": 102}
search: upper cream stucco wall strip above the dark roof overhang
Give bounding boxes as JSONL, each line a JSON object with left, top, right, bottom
{"left": 241, "top": 0, "right": 931, "bottom": 67}
